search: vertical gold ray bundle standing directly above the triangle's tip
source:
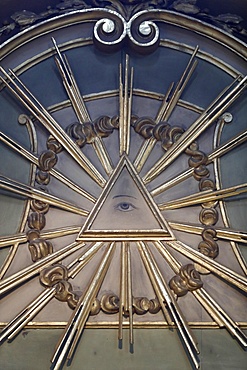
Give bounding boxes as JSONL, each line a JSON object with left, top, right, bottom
{"left": 119, "top": 54, "right": 134, "bottom": 156}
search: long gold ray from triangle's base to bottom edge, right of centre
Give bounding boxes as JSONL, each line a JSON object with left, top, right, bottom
{"left": 138, "top": 242, "right": 199, "bottom": 369}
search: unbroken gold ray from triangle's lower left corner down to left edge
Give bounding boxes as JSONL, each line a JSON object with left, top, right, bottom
{"left": 0, "top": 242, "right": 85, "bottom": 296}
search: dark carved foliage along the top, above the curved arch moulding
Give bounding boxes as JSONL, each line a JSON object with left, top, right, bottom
{"left": 0, "top": 0, "right": 247, "bottom": 40}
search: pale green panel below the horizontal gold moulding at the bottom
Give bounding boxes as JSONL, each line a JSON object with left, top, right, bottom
{"left": 0, "top": 329, "right": 246, "bottom": 370}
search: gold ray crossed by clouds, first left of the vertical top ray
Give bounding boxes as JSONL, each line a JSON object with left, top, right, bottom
{"left": 52, "top": 37, "right": 113, "bottom": 176}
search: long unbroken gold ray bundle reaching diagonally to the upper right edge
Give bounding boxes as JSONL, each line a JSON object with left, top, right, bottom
{"left": 143, "top": 76, "right": 247, "bottom": 184}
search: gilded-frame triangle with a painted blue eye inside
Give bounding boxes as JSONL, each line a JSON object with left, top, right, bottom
{"left": 77, "top": 155, "right": 175, "bottom": 241}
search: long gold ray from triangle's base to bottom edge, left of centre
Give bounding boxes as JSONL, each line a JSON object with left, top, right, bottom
{"left": 51, "top": 242, "right": 115, "bottom": 370}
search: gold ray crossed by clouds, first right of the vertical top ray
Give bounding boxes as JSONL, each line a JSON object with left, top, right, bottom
{"left": 134, "top": 46, "right": 199, "bottom": 172}
